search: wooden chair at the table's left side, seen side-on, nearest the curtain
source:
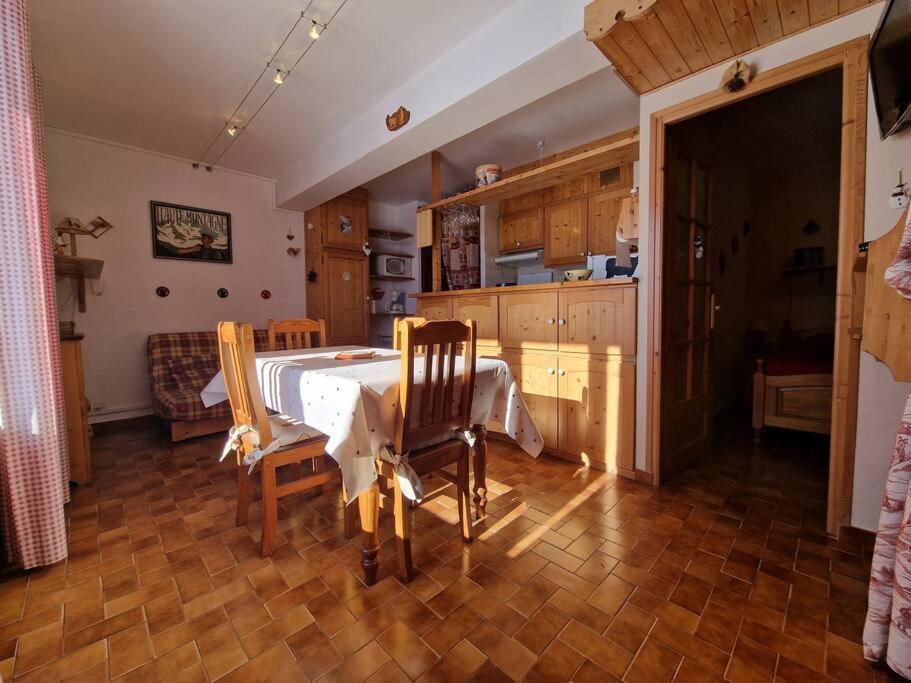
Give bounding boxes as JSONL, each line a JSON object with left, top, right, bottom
{"left": 218, "top": 322, "right": 357, "bottom": 557}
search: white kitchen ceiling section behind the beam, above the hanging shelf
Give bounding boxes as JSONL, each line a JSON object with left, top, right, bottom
{"left": 366, "top": 68, "right": 639, "bottom": 206}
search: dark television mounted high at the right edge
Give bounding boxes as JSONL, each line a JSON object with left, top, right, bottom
{"left": 870, "top": 0, "right": 911, "bottom": 138}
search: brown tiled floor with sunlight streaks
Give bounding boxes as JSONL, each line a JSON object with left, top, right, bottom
{"left": 0, "top": 423, "right": 887, "bottom": 683}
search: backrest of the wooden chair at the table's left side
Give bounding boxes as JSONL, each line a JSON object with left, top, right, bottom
{"left": 218, "top": 322, "right": 272, "bottom": 446}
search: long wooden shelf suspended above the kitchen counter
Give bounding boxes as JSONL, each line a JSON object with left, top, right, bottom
{"left": 418, "top": 129, "right": 639, "bottom": 212}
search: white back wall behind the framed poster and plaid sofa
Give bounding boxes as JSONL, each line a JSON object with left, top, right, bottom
{"left": 47, "top": 130, "right": 307, "bottom": 421}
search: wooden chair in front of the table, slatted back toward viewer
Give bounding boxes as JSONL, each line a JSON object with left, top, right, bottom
{"left": 377, "top": 319, "right": 476, "bottom": 581}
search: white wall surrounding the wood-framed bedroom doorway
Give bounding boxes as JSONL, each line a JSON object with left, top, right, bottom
{"left": 636, "top": 3, "right": 911, "bottom": 529}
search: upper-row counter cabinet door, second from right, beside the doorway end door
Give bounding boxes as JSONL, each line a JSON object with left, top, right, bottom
{"left": 499, "top": 291, "right": 557, "bottom": 351}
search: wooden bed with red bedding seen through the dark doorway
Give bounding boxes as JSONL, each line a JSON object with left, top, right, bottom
{"left": 753, "top": 333, "right": 834, "bottom": 442}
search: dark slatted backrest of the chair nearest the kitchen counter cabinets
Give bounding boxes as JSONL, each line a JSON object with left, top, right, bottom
{"left": 395, "top": 320, "right": 476, "bottom": 453}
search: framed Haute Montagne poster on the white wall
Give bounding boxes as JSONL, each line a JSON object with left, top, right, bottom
{"left": 151, "top": 201, "right": 233, "bottom": 263}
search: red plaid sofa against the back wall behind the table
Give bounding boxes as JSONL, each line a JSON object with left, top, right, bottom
{"left": 147, "top": 330, "right": 282, "bottom": 440}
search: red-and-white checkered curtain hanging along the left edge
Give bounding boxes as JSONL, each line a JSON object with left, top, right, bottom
{"left": 0, "top": 0, "right": 69, "bottom": 568}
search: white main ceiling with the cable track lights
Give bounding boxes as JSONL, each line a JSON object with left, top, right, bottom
{"left": 29, "top": 0, "right": 515, "bottom": 178}
